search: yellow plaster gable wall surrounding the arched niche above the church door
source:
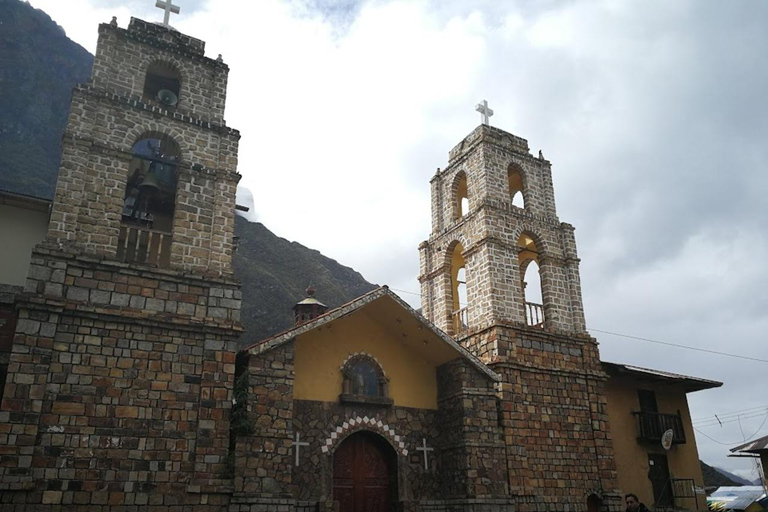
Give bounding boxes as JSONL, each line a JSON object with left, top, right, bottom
{"left": 293, "top": 299, "right": 459, "bottom": 409}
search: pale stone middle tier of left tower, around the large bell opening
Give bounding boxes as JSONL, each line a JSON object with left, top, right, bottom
{"left": 48, "top": 86, "right": 240, "bottom": 275}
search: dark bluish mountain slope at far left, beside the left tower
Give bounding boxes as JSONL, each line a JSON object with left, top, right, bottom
{"left": 0, "top": 0, "right": 93, "bottom": 199}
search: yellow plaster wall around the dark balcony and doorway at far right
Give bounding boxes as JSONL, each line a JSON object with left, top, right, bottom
{"left": 605, "top": 376, "right": 707, "bottom": 510}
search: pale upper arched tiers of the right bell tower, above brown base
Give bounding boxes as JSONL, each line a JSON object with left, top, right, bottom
{"left": 419, "top": 120, "right": 586, "bottom": 344}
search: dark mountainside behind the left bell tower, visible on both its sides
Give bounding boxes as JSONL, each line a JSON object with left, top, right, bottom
{"left": 0, "top": 0, "right": 374, "bottom": 345}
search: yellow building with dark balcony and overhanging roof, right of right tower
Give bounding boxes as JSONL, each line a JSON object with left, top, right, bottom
{"left": 603, "top": 361, "right": 722, "bottom": 510}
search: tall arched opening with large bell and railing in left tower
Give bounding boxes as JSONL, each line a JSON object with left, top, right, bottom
{"left": 117, "top": 133, "right": 180, "bottom": 266}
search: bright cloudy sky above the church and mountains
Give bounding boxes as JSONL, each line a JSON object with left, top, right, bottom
{"left": 25, "top": 0, "right": 768, "bottom": 479}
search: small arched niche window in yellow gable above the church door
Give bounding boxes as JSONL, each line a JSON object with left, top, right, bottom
{"left": 340, "top": 354, "right": 391, "bottom": 404}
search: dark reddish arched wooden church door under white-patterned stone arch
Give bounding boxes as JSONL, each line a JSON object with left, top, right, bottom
{"left": 333, "top": 432, "right": 397, "bottom": 512}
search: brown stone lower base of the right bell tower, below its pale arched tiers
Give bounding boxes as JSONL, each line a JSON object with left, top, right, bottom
{"left": 488, "top": 326, "right": 621, "bottom": 512}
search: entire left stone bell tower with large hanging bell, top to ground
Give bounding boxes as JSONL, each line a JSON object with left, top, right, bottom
{"left": 0, "top": 14, "right": 241, "bottom": 511}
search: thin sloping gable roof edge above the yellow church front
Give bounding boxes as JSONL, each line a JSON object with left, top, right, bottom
{"left": 241, "top": 286, "right": 501, "bottom": 381}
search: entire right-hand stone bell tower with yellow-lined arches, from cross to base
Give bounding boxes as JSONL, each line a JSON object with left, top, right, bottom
{"left": 419, "top": 110, "right": 621, "bottom": 512}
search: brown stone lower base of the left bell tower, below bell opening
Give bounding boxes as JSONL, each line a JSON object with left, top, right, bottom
{"left": 0, "top": 250, "right": 239, "bottom": 512}
